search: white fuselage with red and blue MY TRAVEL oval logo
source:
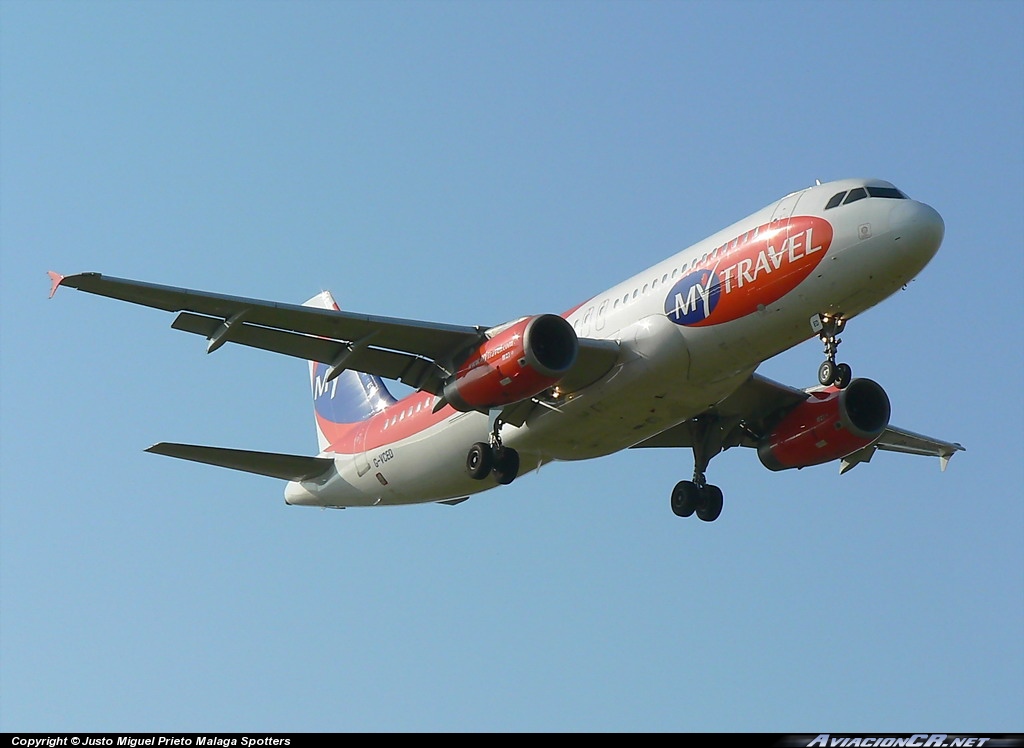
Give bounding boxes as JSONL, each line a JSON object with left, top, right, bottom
{"left": 285, "top": 179, "right": 942, "bottom": 507}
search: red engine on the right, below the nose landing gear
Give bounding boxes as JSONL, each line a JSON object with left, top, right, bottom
{"left": 758, "top": 379, "right": 891, "bottom": 470}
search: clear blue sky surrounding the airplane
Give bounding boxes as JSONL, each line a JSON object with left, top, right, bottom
{"left": 0, "top": 0, "right": 1024, "bottom": 733}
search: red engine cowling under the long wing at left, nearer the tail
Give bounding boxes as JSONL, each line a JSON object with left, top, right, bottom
{"left": 444, "top": 315, "right": 580, "bottom": 411}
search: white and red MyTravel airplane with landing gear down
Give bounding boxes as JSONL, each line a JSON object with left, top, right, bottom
{"left": 48, "top": 179, "right": 964, "bottom": 522}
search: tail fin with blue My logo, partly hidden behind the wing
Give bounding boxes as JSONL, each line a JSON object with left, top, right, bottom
{"left": 303, "top": 291, "right": 397, "bottom": 452}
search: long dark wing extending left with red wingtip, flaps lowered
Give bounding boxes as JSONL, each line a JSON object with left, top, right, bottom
{"left": 49, "top": 272, "right": 618, "bottom": 405}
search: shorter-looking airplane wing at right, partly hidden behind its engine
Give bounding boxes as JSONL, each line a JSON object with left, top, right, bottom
{"left": 634, "top": 374, "right": 964, "bottom": 473}
